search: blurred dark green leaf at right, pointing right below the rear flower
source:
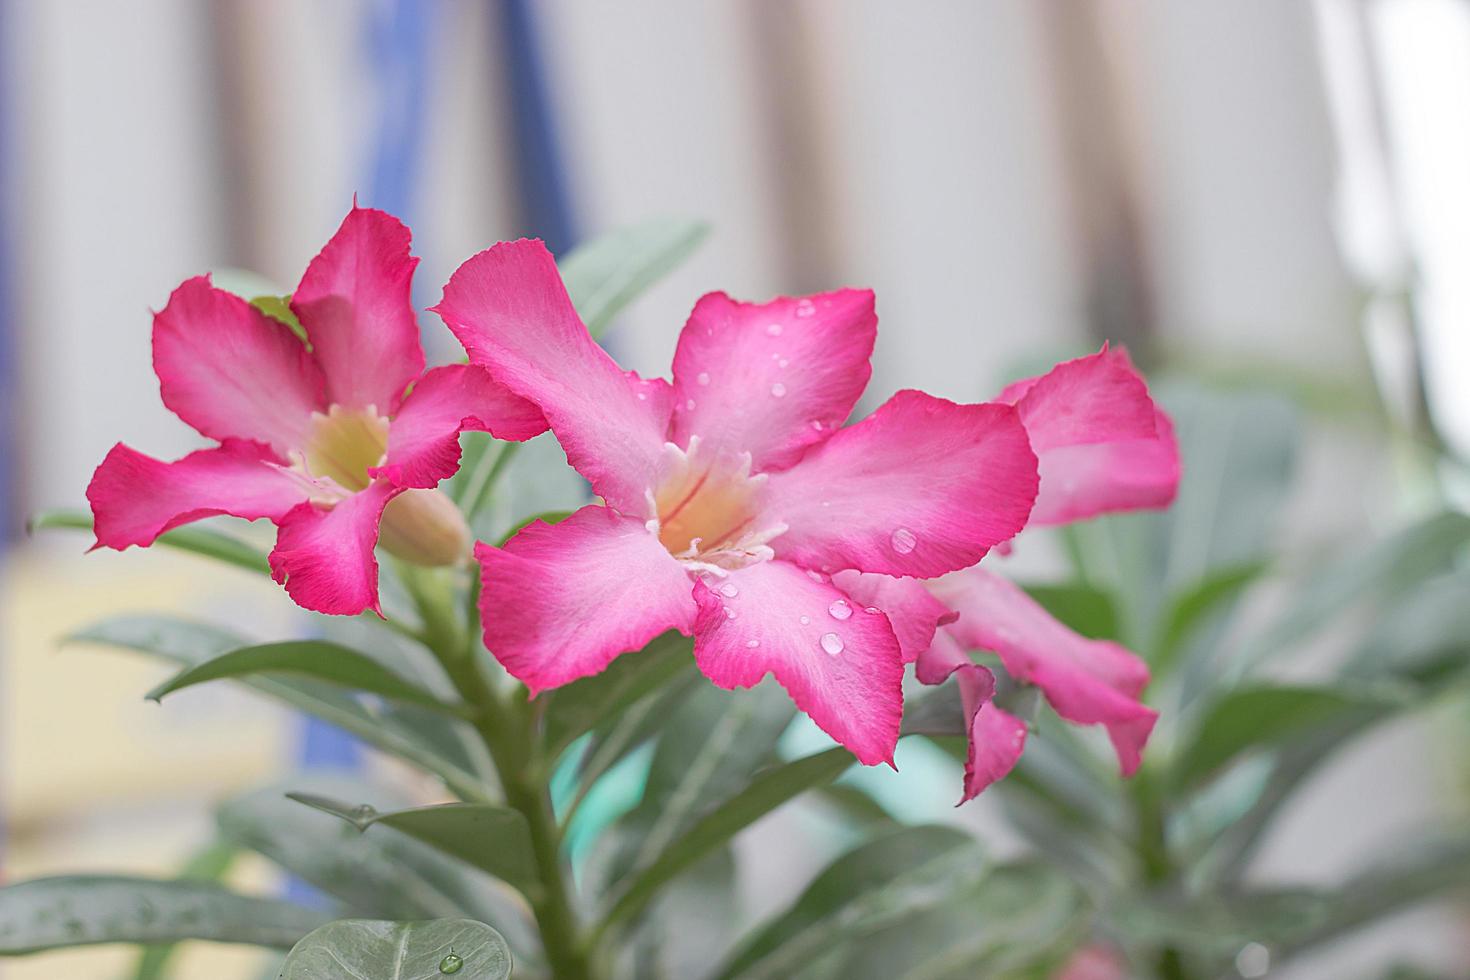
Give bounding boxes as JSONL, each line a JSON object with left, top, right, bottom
{"left": 1175, "top": 685, "right": 1410, "bottom": 788}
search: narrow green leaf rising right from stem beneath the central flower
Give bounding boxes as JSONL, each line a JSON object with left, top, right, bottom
{"left": 603, "top": 748, "right": 853, "bottom": 929}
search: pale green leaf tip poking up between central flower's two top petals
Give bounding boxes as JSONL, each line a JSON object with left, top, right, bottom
{"left": 557, "top": 219, "right": 710, "bottom": 336}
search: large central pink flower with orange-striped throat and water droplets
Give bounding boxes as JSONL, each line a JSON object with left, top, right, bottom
{"left": 437, "top": 241, "right": 1036, "bottom": 764}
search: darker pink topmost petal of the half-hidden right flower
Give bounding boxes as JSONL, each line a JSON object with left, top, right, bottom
{"left": 997, "top": 345, "right": 1154, "bottom": 457}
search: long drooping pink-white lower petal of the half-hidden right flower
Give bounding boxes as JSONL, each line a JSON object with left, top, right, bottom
{"left": 931, "top": 569, "right": 1158, "bottom": 776}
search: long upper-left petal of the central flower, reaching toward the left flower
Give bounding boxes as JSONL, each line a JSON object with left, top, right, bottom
{"left": 434, "top": 239, "right": 670, "bottom": 517}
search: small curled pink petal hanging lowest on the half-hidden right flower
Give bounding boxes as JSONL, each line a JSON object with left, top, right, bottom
{"left": 916, "top": 632, "right": 1026, "bottom": 804}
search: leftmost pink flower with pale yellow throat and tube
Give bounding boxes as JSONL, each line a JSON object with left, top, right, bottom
{"left": 87, "top": 206, "right": 545, "bottom": 616}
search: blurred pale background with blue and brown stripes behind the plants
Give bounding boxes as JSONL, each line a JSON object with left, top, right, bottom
{"left": 0, "top": 0, "right": 1470, "bottom": 980}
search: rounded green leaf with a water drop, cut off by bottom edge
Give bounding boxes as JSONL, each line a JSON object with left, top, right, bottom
{"left": 281, "top": 918, "right": 512, "bottom": 980}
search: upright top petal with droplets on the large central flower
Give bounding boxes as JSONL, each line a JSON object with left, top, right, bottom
{"left": 672, "top": 289, "right": 878, "bottom": 473}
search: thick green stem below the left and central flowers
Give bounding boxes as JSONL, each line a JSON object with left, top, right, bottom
{"left": 404, "top": 569, "right": 600, "bottom": 980}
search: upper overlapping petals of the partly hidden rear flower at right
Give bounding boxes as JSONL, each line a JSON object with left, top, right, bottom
{"left": 1000, "top": 345, "right": 1179, "bottom": 525}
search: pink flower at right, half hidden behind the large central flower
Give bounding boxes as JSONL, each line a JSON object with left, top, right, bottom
{"left": 916, "top": 347, "right": 1179, "bottom": 802}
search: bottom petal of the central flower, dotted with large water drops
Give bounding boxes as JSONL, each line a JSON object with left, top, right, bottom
{"left": 694, "top": 561, "right": 904, "bottom": 765}
